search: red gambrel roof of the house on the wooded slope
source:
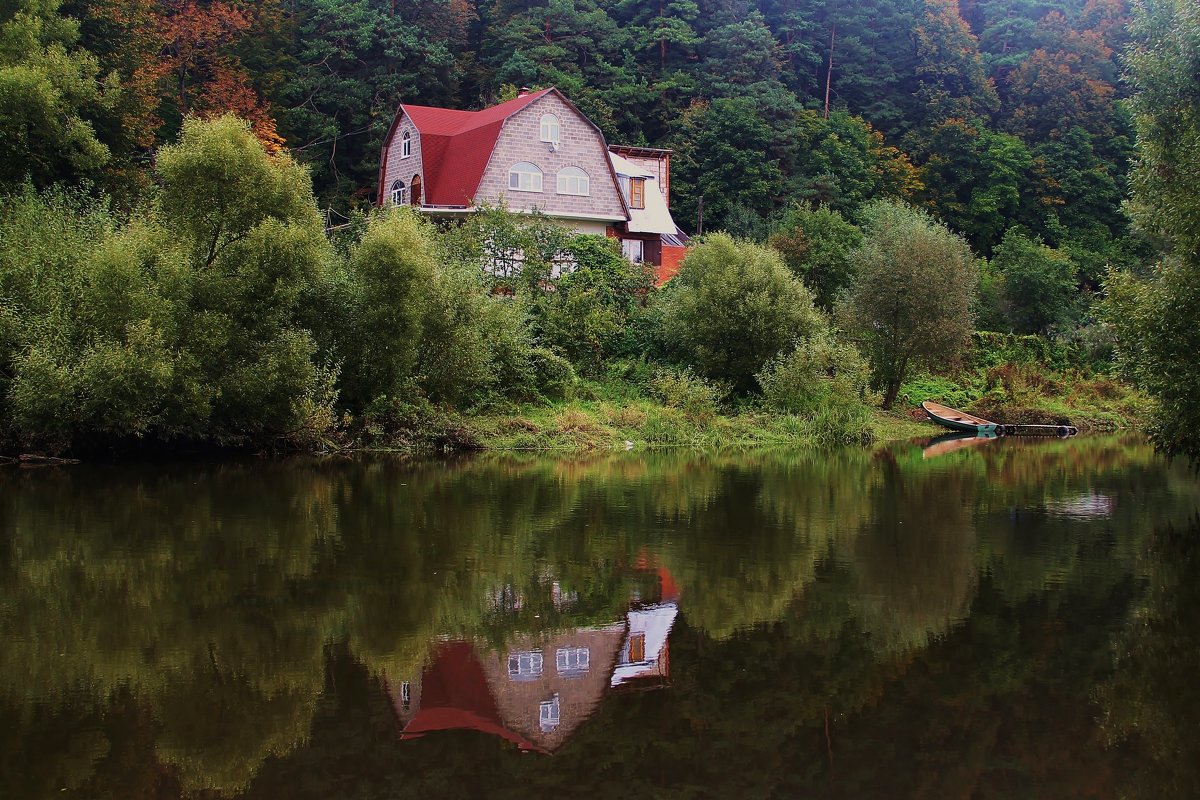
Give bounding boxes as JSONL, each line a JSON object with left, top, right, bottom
{"left": 379, "top": 88, "right": 556, "bottom": 206}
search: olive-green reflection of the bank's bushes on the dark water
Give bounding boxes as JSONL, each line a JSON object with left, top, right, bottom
{"left": 0, "top": 443, "right": 1182, "bottom": 796}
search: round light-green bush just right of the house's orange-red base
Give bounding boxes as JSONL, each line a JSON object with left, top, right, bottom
{"left": 658, "top": 234, "right": 823, "bottom": 390}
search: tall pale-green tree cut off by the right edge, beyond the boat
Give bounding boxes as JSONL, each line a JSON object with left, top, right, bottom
{"left": 1106, "top": 0, "right": 1200, "bottom": 459}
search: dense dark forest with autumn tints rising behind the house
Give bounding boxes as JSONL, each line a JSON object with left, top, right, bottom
{"left": 7, "top": 0, "right": 1132, "bottom": 244}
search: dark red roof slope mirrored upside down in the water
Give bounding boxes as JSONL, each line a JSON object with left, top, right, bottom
{"left": 400, "top": 642, "right": 544, "bottom": 752}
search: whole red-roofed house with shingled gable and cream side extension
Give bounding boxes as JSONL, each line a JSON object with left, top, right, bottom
{"left": 377, "top": 88, "right": 688, "bottom": 282}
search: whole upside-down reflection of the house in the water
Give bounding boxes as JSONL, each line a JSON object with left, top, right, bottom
{"left": 388, "top": 570, "right": 678, "bottom": 753}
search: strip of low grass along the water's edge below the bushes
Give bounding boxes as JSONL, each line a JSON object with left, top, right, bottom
{"left": 367, "top": 365, "right": 1150, "bottom": 452}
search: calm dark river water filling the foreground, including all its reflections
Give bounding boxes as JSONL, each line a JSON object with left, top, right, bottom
{"left": 0, "top": 438, "right": 1200, "bottom": 799}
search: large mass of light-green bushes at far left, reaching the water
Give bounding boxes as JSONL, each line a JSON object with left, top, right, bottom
{"left": 0, "top": 118, "right": 334, "bottom": 447}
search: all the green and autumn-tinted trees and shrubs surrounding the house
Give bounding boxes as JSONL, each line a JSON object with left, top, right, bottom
{"left": 0, "top": 0, "right": 1200, "bottom": 451}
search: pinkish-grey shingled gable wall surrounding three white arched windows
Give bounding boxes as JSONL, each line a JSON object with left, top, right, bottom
{"left": 470, "top": 92, "right": 625, "bottom": 234}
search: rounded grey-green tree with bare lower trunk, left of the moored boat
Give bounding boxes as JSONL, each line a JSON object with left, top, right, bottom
{"left": 841, "top": 201, "right": 978, "bottom": 409}
